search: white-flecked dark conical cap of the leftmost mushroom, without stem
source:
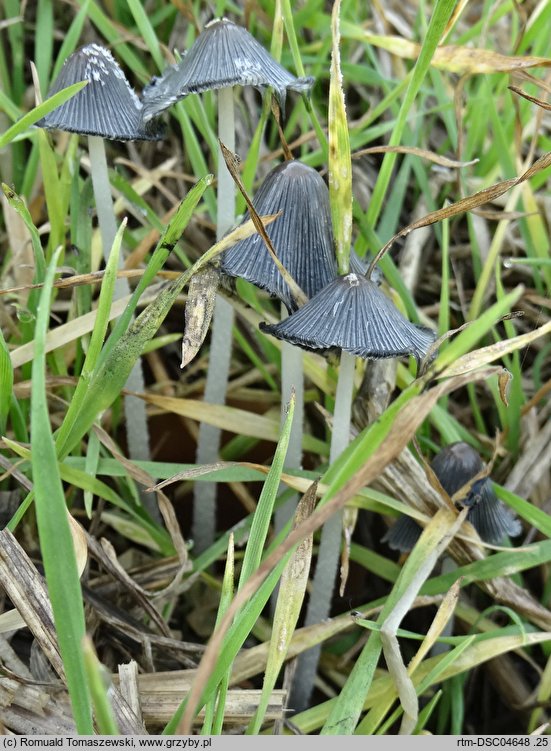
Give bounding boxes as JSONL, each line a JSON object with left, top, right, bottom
{"left": 37, "top": 44, "right": 163, "bottom": 141}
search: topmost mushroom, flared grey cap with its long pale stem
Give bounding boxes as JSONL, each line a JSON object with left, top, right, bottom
{"left": 143, "top": 18, "right": 313, "bottom": 552}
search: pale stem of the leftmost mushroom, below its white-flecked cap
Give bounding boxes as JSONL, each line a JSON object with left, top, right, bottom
{"left": 88, "top": 136, "right": 156, "bottom": 521}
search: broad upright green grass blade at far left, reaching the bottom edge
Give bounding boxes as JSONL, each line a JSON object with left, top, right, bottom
{"left": 31, "top": 251, "right": 93, "bottom": 735}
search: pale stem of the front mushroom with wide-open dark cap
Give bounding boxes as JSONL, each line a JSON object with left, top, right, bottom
{"left": 292, "top": 352, "right": 356, "bottom": 711}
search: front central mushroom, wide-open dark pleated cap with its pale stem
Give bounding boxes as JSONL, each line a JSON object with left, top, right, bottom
{"left": 260, "top": 272, "right": 436, "bottom": 709}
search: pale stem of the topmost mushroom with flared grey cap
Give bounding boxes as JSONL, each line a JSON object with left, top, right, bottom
{"left": 192, "top": 87, "right": 235, "bottom": 553}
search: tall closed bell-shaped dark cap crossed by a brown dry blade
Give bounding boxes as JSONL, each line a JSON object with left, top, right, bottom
{"left": 222, "top": 161, "right": 337, "bottom": 312}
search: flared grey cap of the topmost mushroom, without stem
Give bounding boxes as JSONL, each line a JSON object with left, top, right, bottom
{"left": 143, "top": 18, "right": 314, "bottom": 120}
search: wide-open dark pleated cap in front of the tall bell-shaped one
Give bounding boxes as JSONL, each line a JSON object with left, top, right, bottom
{"left": 260, "top": 274, "right": 436, "bottom": 361}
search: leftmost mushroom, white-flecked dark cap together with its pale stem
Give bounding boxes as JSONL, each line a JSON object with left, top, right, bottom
{"left": 37, "top": 44, "right": 163, "bottom": 518}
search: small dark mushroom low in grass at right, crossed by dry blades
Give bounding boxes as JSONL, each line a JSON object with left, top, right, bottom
{"left": 383, "top": 441, "right": 522, "bottom": 553}
